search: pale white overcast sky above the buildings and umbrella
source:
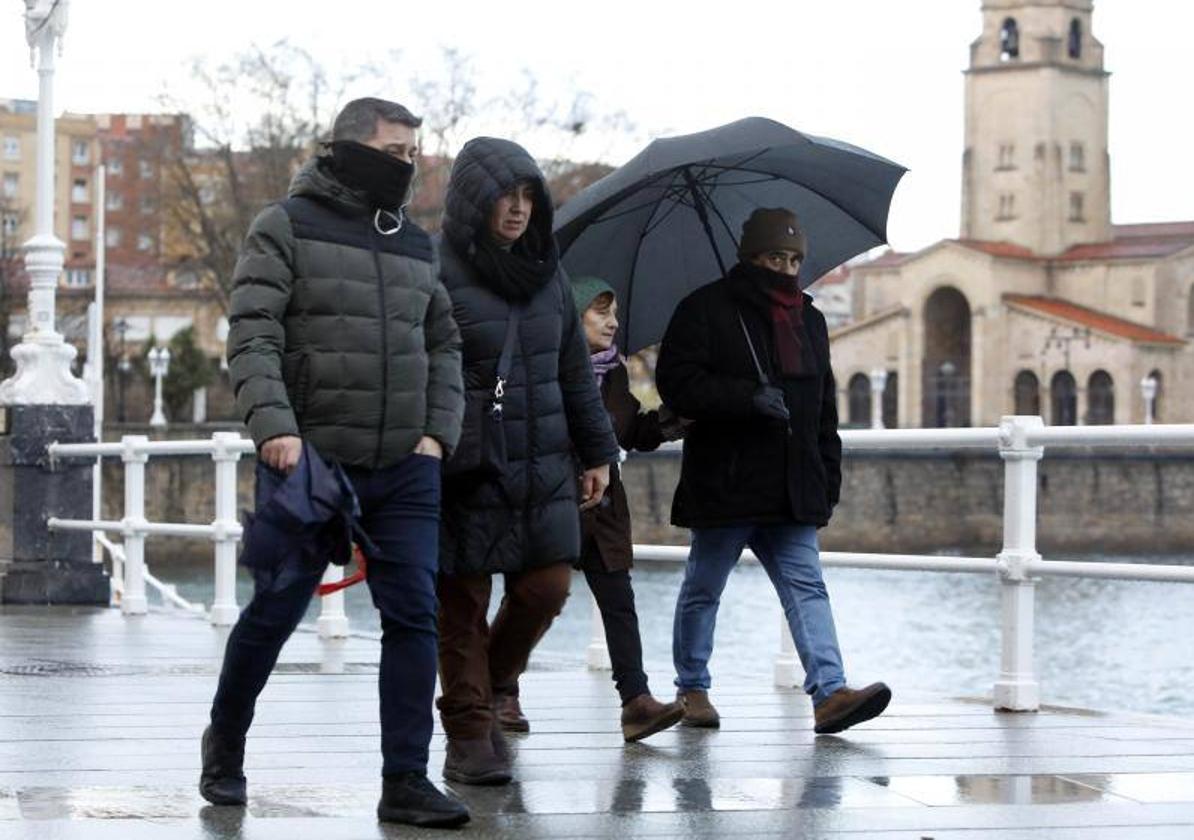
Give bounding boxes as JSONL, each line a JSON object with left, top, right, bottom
{"left": 0, "top": 0, "right": 1194, "bottom": 251}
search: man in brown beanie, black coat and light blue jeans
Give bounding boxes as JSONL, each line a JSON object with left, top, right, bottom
{"left": 656, "top": 208, "right": 891, "bottom": 734}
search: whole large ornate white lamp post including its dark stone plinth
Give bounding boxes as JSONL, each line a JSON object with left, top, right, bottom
{"left": 0, "top": 0, "right": 111, "bottom": 606}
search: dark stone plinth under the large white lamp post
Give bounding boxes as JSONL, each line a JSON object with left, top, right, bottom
{"left": 0, "top": 404, "right": 111, "bottom": 606}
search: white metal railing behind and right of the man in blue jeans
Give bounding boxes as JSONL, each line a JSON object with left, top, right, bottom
{"left": 606, "top": 416, "right": 1194, "bottom": 711}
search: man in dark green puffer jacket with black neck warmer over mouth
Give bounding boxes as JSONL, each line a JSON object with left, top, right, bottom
{"left": 199, "top": 99, "right": 468, "bottom": 826}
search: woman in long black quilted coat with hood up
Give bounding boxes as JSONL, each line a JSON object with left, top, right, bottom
{"left": 438, "top": 137, "right": 617, "bottom": 784}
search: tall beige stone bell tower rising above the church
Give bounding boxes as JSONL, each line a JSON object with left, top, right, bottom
{"left": 961, "top": 0, "right": 1112, "bottom": 257}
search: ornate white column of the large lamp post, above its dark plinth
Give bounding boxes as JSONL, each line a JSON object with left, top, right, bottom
{"left": 0, "top": 0, "right": 91, "bottom": 406}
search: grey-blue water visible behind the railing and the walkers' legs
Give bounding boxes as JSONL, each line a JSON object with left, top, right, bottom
{"left": 152, "top": 556, "right": 1194, "bottom": 717}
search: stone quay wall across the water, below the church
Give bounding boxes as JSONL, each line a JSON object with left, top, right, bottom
{"left": 622, "top": 450, "right": 1194, "bottom": 555}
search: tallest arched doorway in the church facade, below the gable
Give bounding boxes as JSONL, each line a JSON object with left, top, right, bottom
{"left": 921, "top": 286, "right": 971, "bottom": 428}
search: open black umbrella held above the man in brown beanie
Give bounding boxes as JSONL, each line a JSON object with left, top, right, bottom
{"left": 555, "top": 117, "right": 906, "bottom": 353}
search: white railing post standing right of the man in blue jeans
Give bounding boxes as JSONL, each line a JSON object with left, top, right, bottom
{"left": 995, "top": 416, "right": 1045, "bottom": 711}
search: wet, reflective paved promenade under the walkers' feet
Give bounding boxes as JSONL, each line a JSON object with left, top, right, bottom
{"left": 0, "top": 607, "right": 1194, "bottom": 840}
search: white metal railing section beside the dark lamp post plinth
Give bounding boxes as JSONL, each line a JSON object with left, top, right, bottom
{"left": 47, "top": 432, "right": 349, "bottom": 638}
